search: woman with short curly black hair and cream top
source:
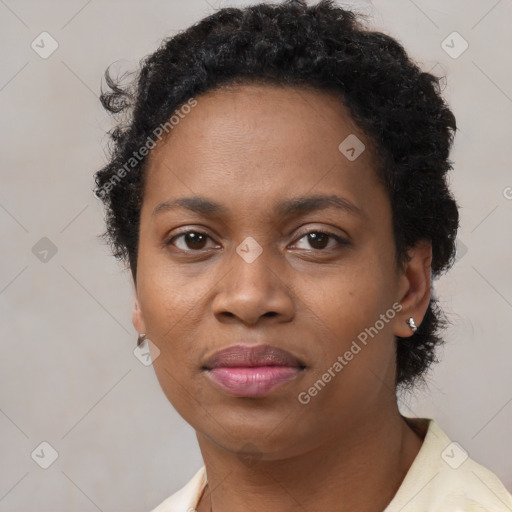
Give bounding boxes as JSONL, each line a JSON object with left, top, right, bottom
{"left": 95, "top": 1, "right": 512, "bottom": 512}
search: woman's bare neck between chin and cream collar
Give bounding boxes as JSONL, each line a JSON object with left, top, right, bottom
{"left": 197, "top": 408, "right": 422, "bottom": 512}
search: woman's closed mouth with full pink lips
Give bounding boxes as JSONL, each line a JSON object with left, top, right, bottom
{"left": 202, "top": 345, "right": 306, "bottom": 397}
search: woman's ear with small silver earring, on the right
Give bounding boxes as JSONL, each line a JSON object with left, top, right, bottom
{"left": 394, "top": 240, "right": 432, "bottom": 338}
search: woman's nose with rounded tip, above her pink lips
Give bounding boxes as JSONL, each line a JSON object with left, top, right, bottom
{"left": 213, "top": 246, "right": 294, "bottom": 325}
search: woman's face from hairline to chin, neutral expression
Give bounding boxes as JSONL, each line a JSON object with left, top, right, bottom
{"left": 133, "top": 85, "right": 428, "bottom": 459}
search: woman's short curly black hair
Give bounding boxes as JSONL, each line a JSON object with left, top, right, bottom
{"left": 94, "top": 0, "right": 459, "bottom": 389}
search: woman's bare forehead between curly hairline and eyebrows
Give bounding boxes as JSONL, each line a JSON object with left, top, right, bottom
{"left": 144, "top": 85, "right": 386, "bottom": 222}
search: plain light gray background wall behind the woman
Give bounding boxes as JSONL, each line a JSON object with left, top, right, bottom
{"left": 0, "top": 0, "right": 512, "bottom": 512}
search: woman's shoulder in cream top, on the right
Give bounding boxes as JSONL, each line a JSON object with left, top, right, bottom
{"left": 385, "top": 419, "right": 512, "bottom": 512}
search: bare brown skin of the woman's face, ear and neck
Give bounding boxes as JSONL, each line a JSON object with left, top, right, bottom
{"left": 133, "top": 85, "right": 431, "bottom": 512}
